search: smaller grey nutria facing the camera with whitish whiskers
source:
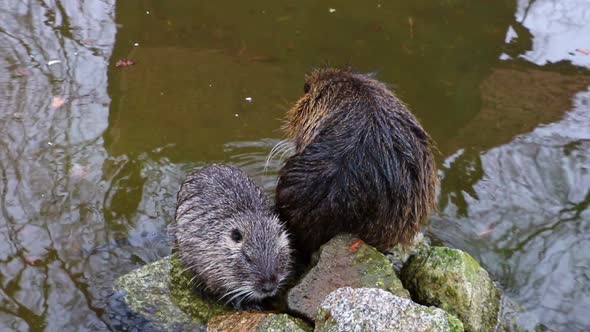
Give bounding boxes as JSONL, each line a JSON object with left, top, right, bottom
{"left": 171, "top": 165, "right": 291, "bottom": 306}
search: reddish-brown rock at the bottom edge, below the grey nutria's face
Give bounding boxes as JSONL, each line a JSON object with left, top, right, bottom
{"left": 207, "top": 311, "right": 312, "bottom": 332}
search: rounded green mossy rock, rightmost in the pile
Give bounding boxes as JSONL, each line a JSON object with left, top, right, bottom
{"left": 401, "top": 247, "right": 501, "bottom": 332}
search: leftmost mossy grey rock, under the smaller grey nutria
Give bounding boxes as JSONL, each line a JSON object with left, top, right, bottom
{"left": 115, "top": 255, "right": 226, "bottom": 331}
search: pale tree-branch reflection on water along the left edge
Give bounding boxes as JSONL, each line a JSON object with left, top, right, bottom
{"left": 0, "top": 0, "right": 116, "bottom": 331}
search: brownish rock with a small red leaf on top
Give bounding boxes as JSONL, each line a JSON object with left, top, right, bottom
{"left": 287, "top": 234, "right": 410, "bottom": 320}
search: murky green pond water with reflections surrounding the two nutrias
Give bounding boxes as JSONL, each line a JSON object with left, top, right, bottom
{"left": 0, "top": 0, "right": 590, "bottom": 331}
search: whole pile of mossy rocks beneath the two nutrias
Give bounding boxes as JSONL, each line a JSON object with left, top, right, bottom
{"left": 111, "top": 234, "right": 501, "bottom": 332}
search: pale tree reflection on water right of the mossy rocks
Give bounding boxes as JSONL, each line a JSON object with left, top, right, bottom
{"left": 433, "top": 90, "right": 590, "bottom": 331}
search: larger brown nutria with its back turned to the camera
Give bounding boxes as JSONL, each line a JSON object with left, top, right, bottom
{"left": 276, "top": 69, "right": 438, "bottom": 257}
